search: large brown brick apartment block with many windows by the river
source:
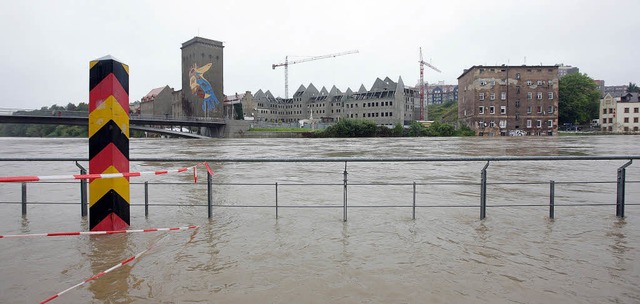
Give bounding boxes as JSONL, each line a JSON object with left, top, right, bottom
{"left": 458, "top": 66, "right": 558, "bottom": 136}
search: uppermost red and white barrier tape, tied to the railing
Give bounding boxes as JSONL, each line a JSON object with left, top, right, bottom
{"left": 0, "top": 162, "right": 213, "bottom": 183}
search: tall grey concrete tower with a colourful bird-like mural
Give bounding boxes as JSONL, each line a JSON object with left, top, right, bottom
{"left": 181, "top": 37, "right": 224, "bottom": 118}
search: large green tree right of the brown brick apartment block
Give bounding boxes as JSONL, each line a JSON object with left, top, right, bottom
{"left": 558, "top": 73, "right": 600, "bottom": 124}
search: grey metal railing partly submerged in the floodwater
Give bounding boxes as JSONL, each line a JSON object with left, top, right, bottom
{"left": 0, "top": 155, "right": 640, "bottom": 221}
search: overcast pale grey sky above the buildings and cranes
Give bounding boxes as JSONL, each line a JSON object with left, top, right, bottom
{"left": 0, "top": 0, "right": 640, "bottom": 108}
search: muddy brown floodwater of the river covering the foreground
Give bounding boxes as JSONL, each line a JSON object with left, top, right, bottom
{"left": 0, "top": 136, "right": 640, "bottom": 303}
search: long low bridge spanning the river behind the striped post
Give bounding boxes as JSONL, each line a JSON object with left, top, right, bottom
{"left": 0, "top": 111, "right": 226, "bottom": 138}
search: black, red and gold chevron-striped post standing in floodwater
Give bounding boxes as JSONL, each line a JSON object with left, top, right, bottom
{"left": 89, "top": 56, "right": 130, "bottom": 231}
